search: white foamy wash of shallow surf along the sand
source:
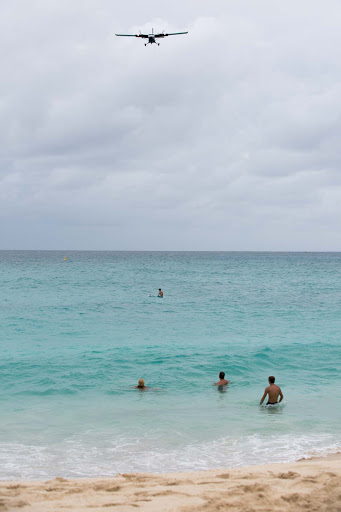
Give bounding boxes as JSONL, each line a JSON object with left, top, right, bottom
{"left": 0, "top": 434, "right": 341, "bottom": 480}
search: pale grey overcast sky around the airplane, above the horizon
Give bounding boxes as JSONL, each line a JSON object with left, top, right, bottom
{"left": 0, "top": 0, "right": 341, "bottom": 251}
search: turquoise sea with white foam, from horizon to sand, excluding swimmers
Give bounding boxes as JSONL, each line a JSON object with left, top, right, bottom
{"left": 0, "top": 251, "right": 341, "bottom": 479}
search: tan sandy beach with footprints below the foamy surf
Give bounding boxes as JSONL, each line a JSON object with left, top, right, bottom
{"left": 0, "top": 454, "right": 341, "bottom": 512}
